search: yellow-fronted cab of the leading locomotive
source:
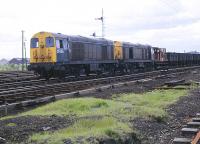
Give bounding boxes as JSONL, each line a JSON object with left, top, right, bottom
{"left": 28, "top": 32, "right": 67, "bottom": 78}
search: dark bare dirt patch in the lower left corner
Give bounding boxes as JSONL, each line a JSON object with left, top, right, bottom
{"left": 0, "top": 115, "right": 74, "bottom": 143}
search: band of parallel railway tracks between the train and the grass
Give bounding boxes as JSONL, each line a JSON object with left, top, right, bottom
{"left": 0, "top": 67, "right": 200, "bottom": 116}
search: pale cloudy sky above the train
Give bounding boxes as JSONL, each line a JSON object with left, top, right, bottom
{"left": 0, "top": 0, "right": 200, "bottom": 59}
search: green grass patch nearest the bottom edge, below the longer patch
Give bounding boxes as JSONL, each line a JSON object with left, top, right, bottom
{"left": 29, "top": 117, "right": 132, "bottom": 144}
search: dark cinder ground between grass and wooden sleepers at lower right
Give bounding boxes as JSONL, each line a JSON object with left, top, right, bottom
{"left": 132, "top": 89, "right": 200, "bottom": 144}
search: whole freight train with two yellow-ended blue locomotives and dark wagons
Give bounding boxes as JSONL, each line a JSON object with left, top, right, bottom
{"left": 28, "top": 32, "right": 200, "bottom": 78}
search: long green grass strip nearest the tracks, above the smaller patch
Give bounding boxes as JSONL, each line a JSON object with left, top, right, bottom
{"left": 21, "top": 90, "right": 187, "bottom": 118}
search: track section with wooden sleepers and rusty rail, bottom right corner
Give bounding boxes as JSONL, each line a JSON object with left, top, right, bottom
{"left": 173, "top": 113, "right": 200, "bottom": 144}
